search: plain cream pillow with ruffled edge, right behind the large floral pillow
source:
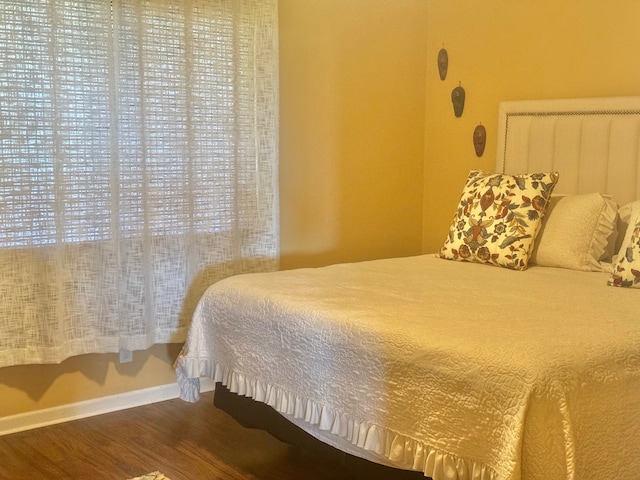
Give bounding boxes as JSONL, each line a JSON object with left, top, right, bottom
{"left": 529, "top": 193, "right": 618, "bottom": 272}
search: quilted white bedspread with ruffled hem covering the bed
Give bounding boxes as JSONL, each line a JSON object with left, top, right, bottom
{"left": 176, "top": 255, "right": 640, "bottom": 480}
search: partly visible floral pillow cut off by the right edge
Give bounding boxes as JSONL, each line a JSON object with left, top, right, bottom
{"left": 607, "top": 201, "right": 640, "bottom": 288}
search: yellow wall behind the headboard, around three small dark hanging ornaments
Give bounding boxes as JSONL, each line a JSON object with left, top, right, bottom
{"left": 423, "top": 0, "right": 640, "bottom": 252}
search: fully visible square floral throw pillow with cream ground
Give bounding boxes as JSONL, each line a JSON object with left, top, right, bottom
{"left": 438, "top": 170, "right": 558, "bottom": 270}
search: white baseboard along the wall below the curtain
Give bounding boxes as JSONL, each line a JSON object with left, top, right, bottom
{"left": 0, "top": 378, "right": 215, "bottom": 436}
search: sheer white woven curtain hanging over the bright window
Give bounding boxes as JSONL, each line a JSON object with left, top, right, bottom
{"left": 0, "top": 0, "right": 278, "bottom": 367}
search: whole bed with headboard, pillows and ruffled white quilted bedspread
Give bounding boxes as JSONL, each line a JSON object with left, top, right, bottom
{"left": 176, "top": 97, "right": 640, "bottom": 480}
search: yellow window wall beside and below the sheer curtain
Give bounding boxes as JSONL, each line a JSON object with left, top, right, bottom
{"left": 0, "top": 0, "right": 426, "bottom": 417}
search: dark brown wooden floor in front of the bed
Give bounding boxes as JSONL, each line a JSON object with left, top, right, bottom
{"left": 0, "top": 393, "right": 360, "bottom": 480}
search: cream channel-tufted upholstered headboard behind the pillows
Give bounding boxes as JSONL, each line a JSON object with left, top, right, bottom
{"left": 496, "top": 97, "right": 640, "bottom": 205}
